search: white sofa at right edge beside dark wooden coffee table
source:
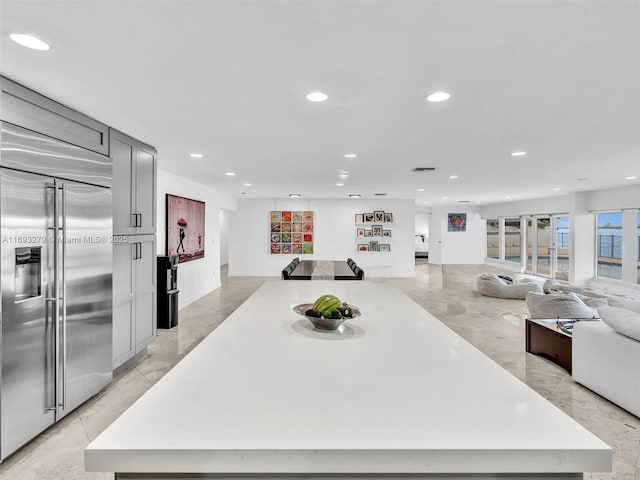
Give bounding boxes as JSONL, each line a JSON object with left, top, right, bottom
{"left": 571, "top": 321, "right": 640, "bottom": 417}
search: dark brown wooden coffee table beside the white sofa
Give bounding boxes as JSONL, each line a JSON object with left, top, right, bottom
{"left": 525, "top": 318, "right": 571, "bottom": 373}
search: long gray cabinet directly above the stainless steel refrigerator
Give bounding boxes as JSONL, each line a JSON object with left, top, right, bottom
{"left": 0, "top": 77, "right": 109, "bottom": 155}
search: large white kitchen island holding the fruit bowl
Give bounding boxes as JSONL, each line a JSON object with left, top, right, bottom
{"left": 85, "top": 280, "right": 612, "bottom": 480}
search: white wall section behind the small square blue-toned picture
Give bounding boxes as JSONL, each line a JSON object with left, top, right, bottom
{"left": 429, "top": 207, "right": 486, "bottom": 265}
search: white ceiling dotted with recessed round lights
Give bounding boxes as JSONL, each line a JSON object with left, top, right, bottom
{"left": 0, "top": 0, "right": 640, "bottom": 205}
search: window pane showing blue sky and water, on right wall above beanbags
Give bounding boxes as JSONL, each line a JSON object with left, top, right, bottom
{"left": 596, "top": 212, "right": 622, "bottom": 280}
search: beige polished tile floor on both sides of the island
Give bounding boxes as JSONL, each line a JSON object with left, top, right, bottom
{"left": 0, "top": 259, "right": 640, "bottom": 480}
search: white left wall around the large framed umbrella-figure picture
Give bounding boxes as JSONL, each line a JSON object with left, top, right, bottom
{"left": 157, "top": 170, "right": 235, "bottom": 308}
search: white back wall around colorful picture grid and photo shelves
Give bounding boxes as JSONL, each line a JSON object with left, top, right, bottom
{"left": 229, "top": 198, "right": 415, "bottom": 278}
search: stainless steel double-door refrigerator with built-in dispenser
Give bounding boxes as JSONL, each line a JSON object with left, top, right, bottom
{"left": 0, "top": 122, "right": 112, "bottom": 460}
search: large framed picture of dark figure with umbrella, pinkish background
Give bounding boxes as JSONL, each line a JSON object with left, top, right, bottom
{"left": 165, "top": 193, "right": 205, "bottom": 263}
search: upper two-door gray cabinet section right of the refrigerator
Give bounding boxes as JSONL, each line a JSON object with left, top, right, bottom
{"left": 110, "top": 129, "right": 157, "bottom": 235}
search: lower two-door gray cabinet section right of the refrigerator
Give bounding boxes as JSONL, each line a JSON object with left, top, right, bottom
{"left": 113, "top": 235, "right": 156, "bottom": 369}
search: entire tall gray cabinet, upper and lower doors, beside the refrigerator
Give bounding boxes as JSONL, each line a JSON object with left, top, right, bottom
{"left": 109, "top": 130, "right": 157, "bottom": 370}
